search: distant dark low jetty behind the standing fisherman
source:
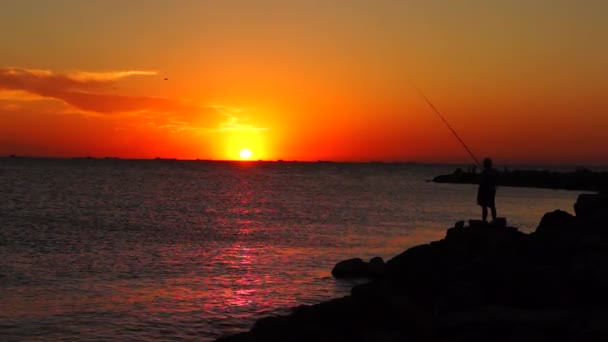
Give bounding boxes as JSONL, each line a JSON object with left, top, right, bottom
{"left": 433, "top": 169, "right": 608, "bottom": 191}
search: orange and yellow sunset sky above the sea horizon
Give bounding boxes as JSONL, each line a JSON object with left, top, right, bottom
{"left": 0, "top": 0, "right": 608, "bottom": 164}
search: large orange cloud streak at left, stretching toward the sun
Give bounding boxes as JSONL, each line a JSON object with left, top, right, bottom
{"left": 0, "top": 68, "right": 265, "bottom": 132}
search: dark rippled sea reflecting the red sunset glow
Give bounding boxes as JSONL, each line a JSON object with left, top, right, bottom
{"left": 0, "top": 158, "right": 580, "bottom": 341}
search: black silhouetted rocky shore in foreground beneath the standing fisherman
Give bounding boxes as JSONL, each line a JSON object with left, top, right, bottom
{"left": 217, "top": 194, "right": 608, "bottom": 342}
